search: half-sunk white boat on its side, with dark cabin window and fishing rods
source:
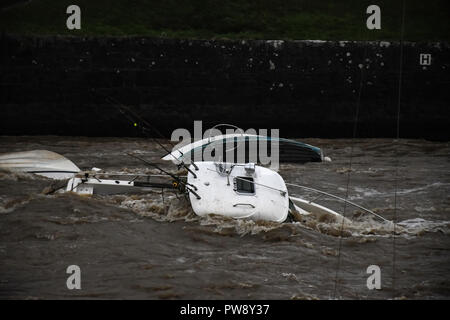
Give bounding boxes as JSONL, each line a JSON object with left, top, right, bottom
{"left": 65, "top": 161, "right": 356, "bottom": 222}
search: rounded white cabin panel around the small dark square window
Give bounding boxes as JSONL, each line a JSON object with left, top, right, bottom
{"left": 187, "top": 161, "right": 289, "bottom": 222}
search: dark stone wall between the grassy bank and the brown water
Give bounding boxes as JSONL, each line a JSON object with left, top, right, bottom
{"left": 0, "top": 35, "right": 450, "bottom": 140}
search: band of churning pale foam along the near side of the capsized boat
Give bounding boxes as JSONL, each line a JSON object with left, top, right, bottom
{"left": 103, "top": 192, "right": 450, "bottom": 237}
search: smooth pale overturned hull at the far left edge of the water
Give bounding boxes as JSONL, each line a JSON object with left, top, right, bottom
{"left": 0, "top": 150, "right": 80, "bottom": 180}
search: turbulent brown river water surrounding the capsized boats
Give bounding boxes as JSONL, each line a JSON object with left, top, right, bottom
{"left": 0, "top": 137, "right": 450, "bottom": 299}
